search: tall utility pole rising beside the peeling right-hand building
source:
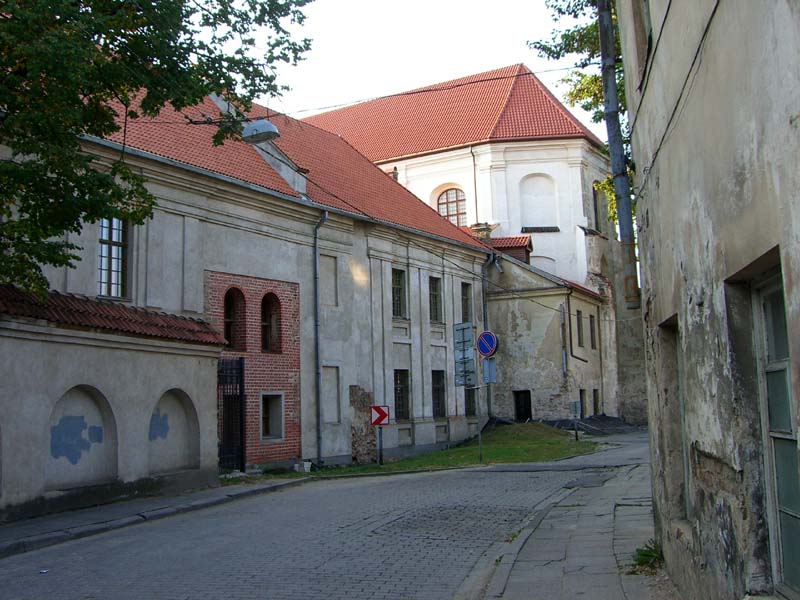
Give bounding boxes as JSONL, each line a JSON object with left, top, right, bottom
{"left": 597, "top": 0, "right": 641, "bottom": 308}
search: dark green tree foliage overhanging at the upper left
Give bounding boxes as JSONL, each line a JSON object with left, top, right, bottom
{"left": 0, "top": 0, "right": 311, "bottom": 292}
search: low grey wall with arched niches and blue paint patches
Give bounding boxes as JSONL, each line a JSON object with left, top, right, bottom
{"left": 0, "top": 317, "right": 218, "bottom": 520}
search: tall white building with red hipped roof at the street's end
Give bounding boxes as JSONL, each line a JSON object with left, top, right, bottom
{"left": 306, "top": 64, "right": 646, "bottom": 422}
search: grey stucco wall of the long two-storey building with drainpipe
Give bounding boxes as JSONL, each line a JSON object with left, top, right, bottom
{"left": 42, "top": 145, "right": 486, "bottom": 463}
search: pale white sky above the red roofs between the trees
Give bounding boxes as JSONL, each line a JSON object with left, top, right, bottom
{"left": 267, "top": 0, "right": 606, "bottom": 139}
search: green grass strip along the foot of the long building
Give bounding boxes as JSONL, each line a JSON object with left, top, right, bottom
{"left": 313, "top": 423, "right": 596, "bottom": 475}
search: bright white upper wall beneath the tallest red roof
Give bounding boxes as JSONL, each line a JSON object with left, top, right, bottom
{"left": 381, "top": 140, "right": 608, "bottom": 283}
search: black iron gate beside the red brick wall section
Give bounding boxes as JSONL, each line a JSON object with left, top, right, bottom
{"left": 217, "top": 358, "right": 245, "bottom": 471}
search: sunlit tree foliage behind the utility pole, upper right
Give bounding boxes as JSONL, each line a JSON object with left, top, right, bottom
{"left": 530, "top": 0, "right": 632, "bottom": 221}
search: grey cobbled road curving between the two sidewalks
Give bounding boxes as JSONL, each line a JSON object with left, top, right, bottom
{"left": 0, "top": 434, "right": 647, "bottom": 600}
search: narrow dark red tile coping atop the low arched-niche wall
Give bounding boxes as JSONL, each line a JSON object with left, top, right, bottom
{"left": 0, "top": 285, "right": 225, "bottom": 346}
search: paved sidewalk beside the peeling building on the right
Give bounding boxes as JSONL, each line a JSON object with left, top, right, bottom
{"left": 485, "top": 464, "right": 678, "bottom": 600}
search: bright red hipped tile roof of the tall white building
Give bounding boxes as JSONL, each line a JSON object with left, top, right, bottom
{"left": 305, "top": 64, "right": 602, "bottom": 162}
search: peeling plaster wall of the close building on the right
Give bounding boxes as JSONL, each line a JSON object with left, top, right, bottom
{"left": 617, "top": 0, "right": 800, "bottom": 600}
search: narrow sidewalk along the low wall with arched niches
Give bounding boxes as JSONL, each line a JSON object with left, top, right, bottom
{"left": 0, "top": 477, "right": 308, "bottom": 558}
